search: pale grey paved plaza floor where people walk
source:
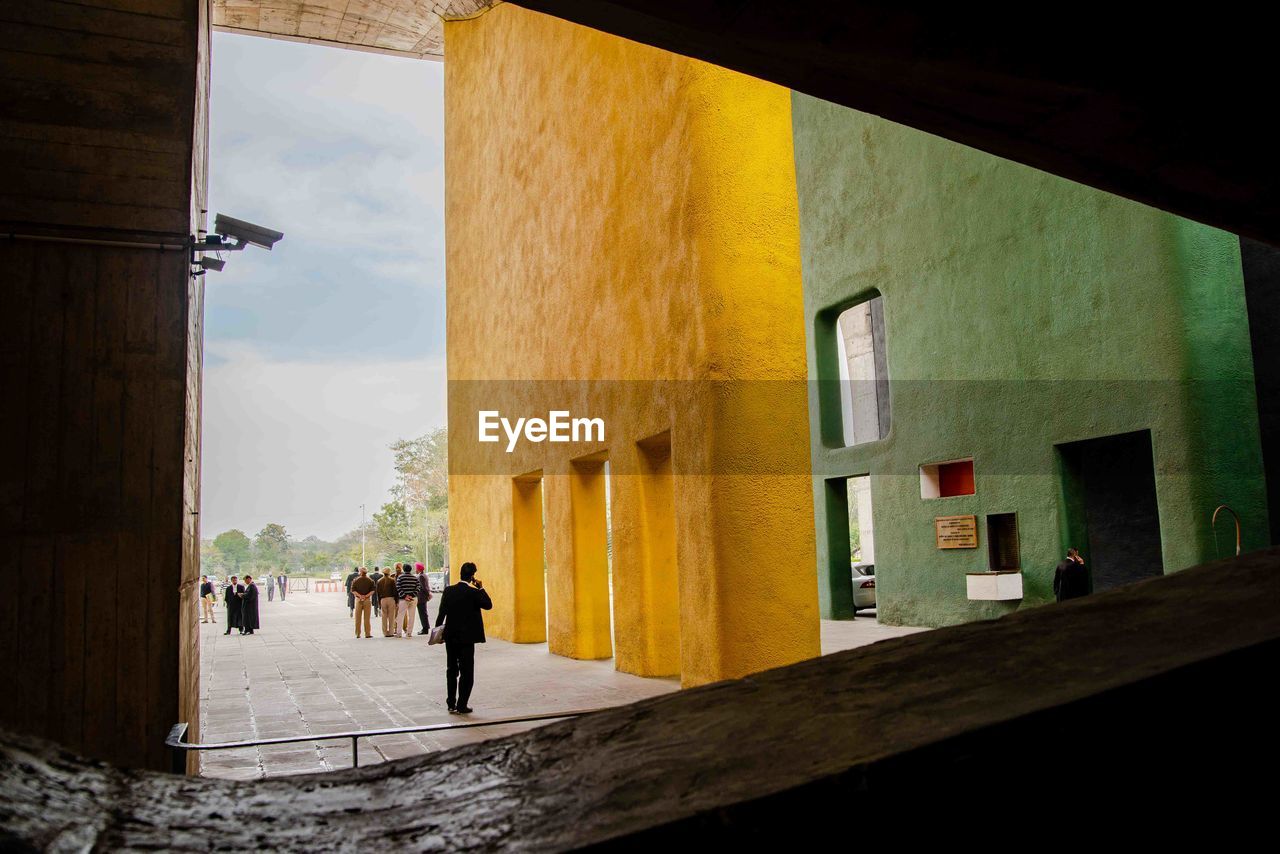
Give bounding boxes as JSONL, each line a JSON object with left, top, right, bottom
{"left": 200, "top": 593, "right": 915, "bottom": 780}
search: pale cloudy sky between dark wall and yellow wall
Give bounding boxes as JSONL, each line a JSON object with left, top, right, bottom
{"left": 201, "top": 33, "right": 445, "bottom": 539}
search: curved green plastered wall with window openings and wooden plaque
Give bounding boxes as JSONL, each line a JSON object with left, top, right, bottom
{"left": 792, "top": 93, "right": 1267, "bottom": 626}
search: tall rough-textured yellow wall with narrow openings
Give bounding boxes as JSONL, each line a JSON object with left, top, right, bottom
{"left": 445, "top": 5, "right": 818, "bottom": 685}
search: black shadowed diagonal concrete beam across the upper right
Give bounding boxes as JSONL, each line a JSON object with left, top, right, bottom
{"left": 518, "top": 0, "right": 1280, "bottom": 243}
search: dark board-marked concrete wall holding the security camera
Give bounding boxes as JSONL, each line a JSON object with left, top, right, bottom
{"left": 0, "top": 0, "right": 209, "bottom": 768}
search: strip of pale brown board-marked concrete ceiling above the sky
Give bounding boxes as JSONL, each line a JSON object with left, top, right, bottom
{"left": 214, "top": 0, "right": 498, "bottom": 59}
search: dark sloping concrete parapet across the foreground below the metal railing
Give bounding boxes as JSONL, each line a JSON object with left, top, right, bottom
{"left": 0, "top": 549, "right": 1280, "bottom": 851}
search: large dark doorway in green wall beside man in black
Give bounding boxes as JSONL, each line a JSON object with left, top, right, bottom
{"left": 1057, "top": 430, "right": 1165, "bottom": 590}
